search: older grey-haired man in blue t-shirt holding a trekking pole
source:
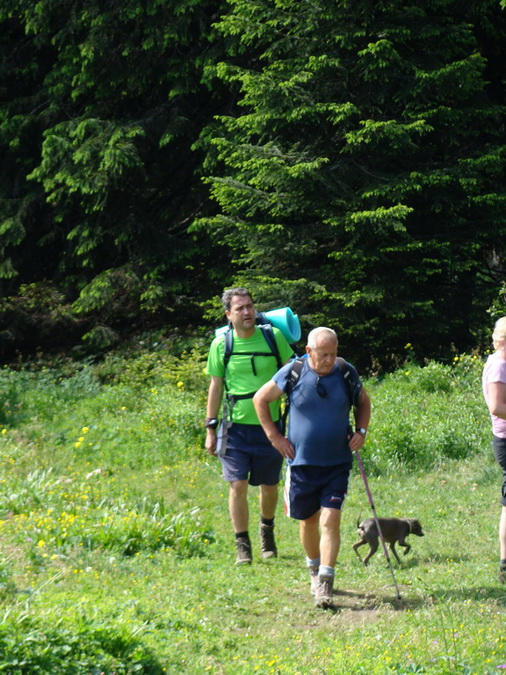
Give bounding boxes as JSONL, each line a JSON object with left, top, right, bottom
{"left": 253, "top": 327, "right": 371, "bottom": 607}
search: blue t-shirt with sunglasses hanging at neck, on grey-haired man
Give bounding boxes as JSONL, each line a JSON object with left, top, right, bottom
{"left": 273, "top": 359, "right": 353, "bottom": 466}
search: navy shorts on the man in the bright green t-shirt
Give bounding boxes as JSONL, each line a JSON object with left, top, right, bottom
{"left": 220, "top": 423, "right": 283, "bottom": 485}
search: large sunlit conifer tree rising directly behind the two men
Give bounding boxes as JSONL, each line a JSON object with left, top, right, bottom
{"left": 200, "top": 0, "right": 506, "bottom": 362}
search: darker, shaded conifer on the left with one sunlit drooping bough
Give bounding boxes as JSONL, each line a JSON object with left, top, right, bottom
{"left": 0, "top": 0, "right": 228, "bottom": 342}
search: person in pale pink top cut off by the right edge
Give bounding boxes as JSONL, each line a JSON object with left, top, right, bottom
{"left": 482, "top": 316, "right": 506, "bottom": 583}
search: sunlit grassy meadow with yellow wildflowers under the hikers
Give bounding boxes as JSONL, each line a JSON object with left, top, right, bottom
{"left": 0, "top": 343, "right": 506, "bottom": 675}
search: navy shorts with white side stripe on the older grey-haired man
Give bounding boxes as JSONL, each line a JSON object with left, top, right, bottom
{"left": 285, "top": 462, "right": 352, "bottom": 520}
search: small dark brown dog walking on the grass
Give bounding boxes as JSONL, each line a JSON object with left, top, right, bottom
{"left": 353, "top": 518, "right": 424, "bottom": 565}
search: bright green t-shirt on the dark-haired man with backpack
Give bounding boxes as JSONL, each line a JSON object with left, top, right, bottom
{"left": 206, "top": 326, "right": 293, "bottom": 424}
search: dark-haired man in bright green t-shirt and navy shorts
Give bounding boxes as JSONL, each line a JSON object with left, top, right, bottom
{"left": 206, "top": 288, "right": 293, "bottom": 564}
